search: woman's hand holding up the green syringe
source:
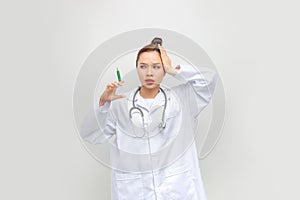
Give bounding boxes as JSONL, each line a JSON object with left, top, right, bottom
{"left": 99, "top": 81, "right": 125, "bottom": 107}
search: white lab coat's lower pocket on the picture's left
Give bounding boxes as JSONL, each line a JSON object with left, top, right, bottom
{"left": 115, "top": 172, "right": 144, "bottom": 200}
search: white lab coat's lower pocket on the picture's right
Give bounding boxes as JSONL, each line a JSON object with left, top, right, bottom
{"left": 163, "top": 167, "right": 197, "bottom": 200}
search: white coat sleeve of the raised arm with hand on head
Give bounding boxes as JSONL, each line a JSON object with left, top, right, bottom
{"left": 174, "top": 65, "right": 217, "bottom": 117}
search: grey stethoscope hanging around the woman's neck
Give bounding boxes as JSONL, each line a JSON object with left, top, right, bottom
{"left": 129, "top": 87, "right": 167, "bottom": 129}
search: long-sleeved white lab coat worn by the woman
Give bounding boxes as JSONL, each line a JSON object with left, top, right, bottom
{"left": 80, "top": 65, "right": 216, "bottom": 200}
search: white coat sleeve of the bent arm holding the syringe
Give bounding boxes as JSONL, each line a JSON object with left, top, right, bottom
{"left": 79, "top": 102, "right": 116, "bottom": 144}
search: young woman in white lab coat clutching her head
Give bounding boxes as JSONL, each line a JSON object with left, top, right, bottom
{"left": 81, "top": 38, "right": 216, "bottom": 200}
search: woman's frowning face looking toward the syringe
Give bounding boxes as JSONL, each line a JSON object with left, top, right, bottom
{"left": 137, "top": 51, "right": 165, "bottom": 89}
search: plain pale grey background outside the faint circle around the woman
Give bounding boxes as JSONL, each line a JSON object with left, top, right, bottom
{"left": 0, "top": 0, "right": 300, "bottom": 200}
